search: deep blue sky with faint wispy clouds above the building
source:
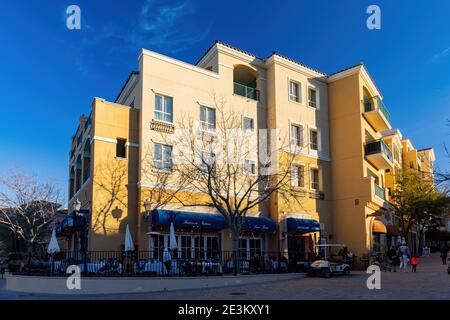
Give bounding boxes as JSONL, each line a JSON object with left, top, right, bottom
{"left": 0, "top": 0, "right": 450, "bottom": 200}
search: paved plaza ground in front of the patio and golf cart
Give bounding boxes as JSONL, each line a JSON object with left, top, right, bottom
{"left": 0, "top": 254, "right": 450, "bottom": 300}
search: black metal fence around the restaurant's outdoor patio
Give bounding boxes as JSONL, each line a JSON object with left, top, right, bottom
{"left": 14, "top": 251, "right": 311, "bottom": 277}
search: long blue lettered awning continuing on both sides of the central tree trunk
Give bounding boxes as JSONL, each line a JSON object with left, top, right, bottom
{"left": 152, "top": 210, "right": 276, "bottom": 232}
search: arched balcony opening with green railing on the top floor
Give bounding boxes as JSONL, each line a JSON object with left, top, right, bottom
{"left": 233, "top": 65, "right": 259, "bottom": 100}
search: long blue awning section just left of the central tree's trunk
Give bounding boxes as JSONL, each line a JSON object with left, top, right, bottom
{"left": 152, "top": 210, "right": 228, "bottom": 229}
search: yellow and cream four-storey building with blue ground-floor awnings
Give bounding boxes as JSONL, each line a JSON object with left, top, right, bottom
{"left": 58, "top": 42, "right": 434, "bottom": 259}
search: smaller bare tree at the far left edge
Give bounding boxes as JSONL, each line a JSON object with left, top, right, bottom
{"left": 0, "top": 172, "right": 63, "bottom": 259}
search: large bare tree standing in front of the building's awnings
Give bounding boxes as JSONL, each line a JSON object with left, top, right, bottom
{"left": 168, "top": 96, "right": 301, "bottom": 272}
